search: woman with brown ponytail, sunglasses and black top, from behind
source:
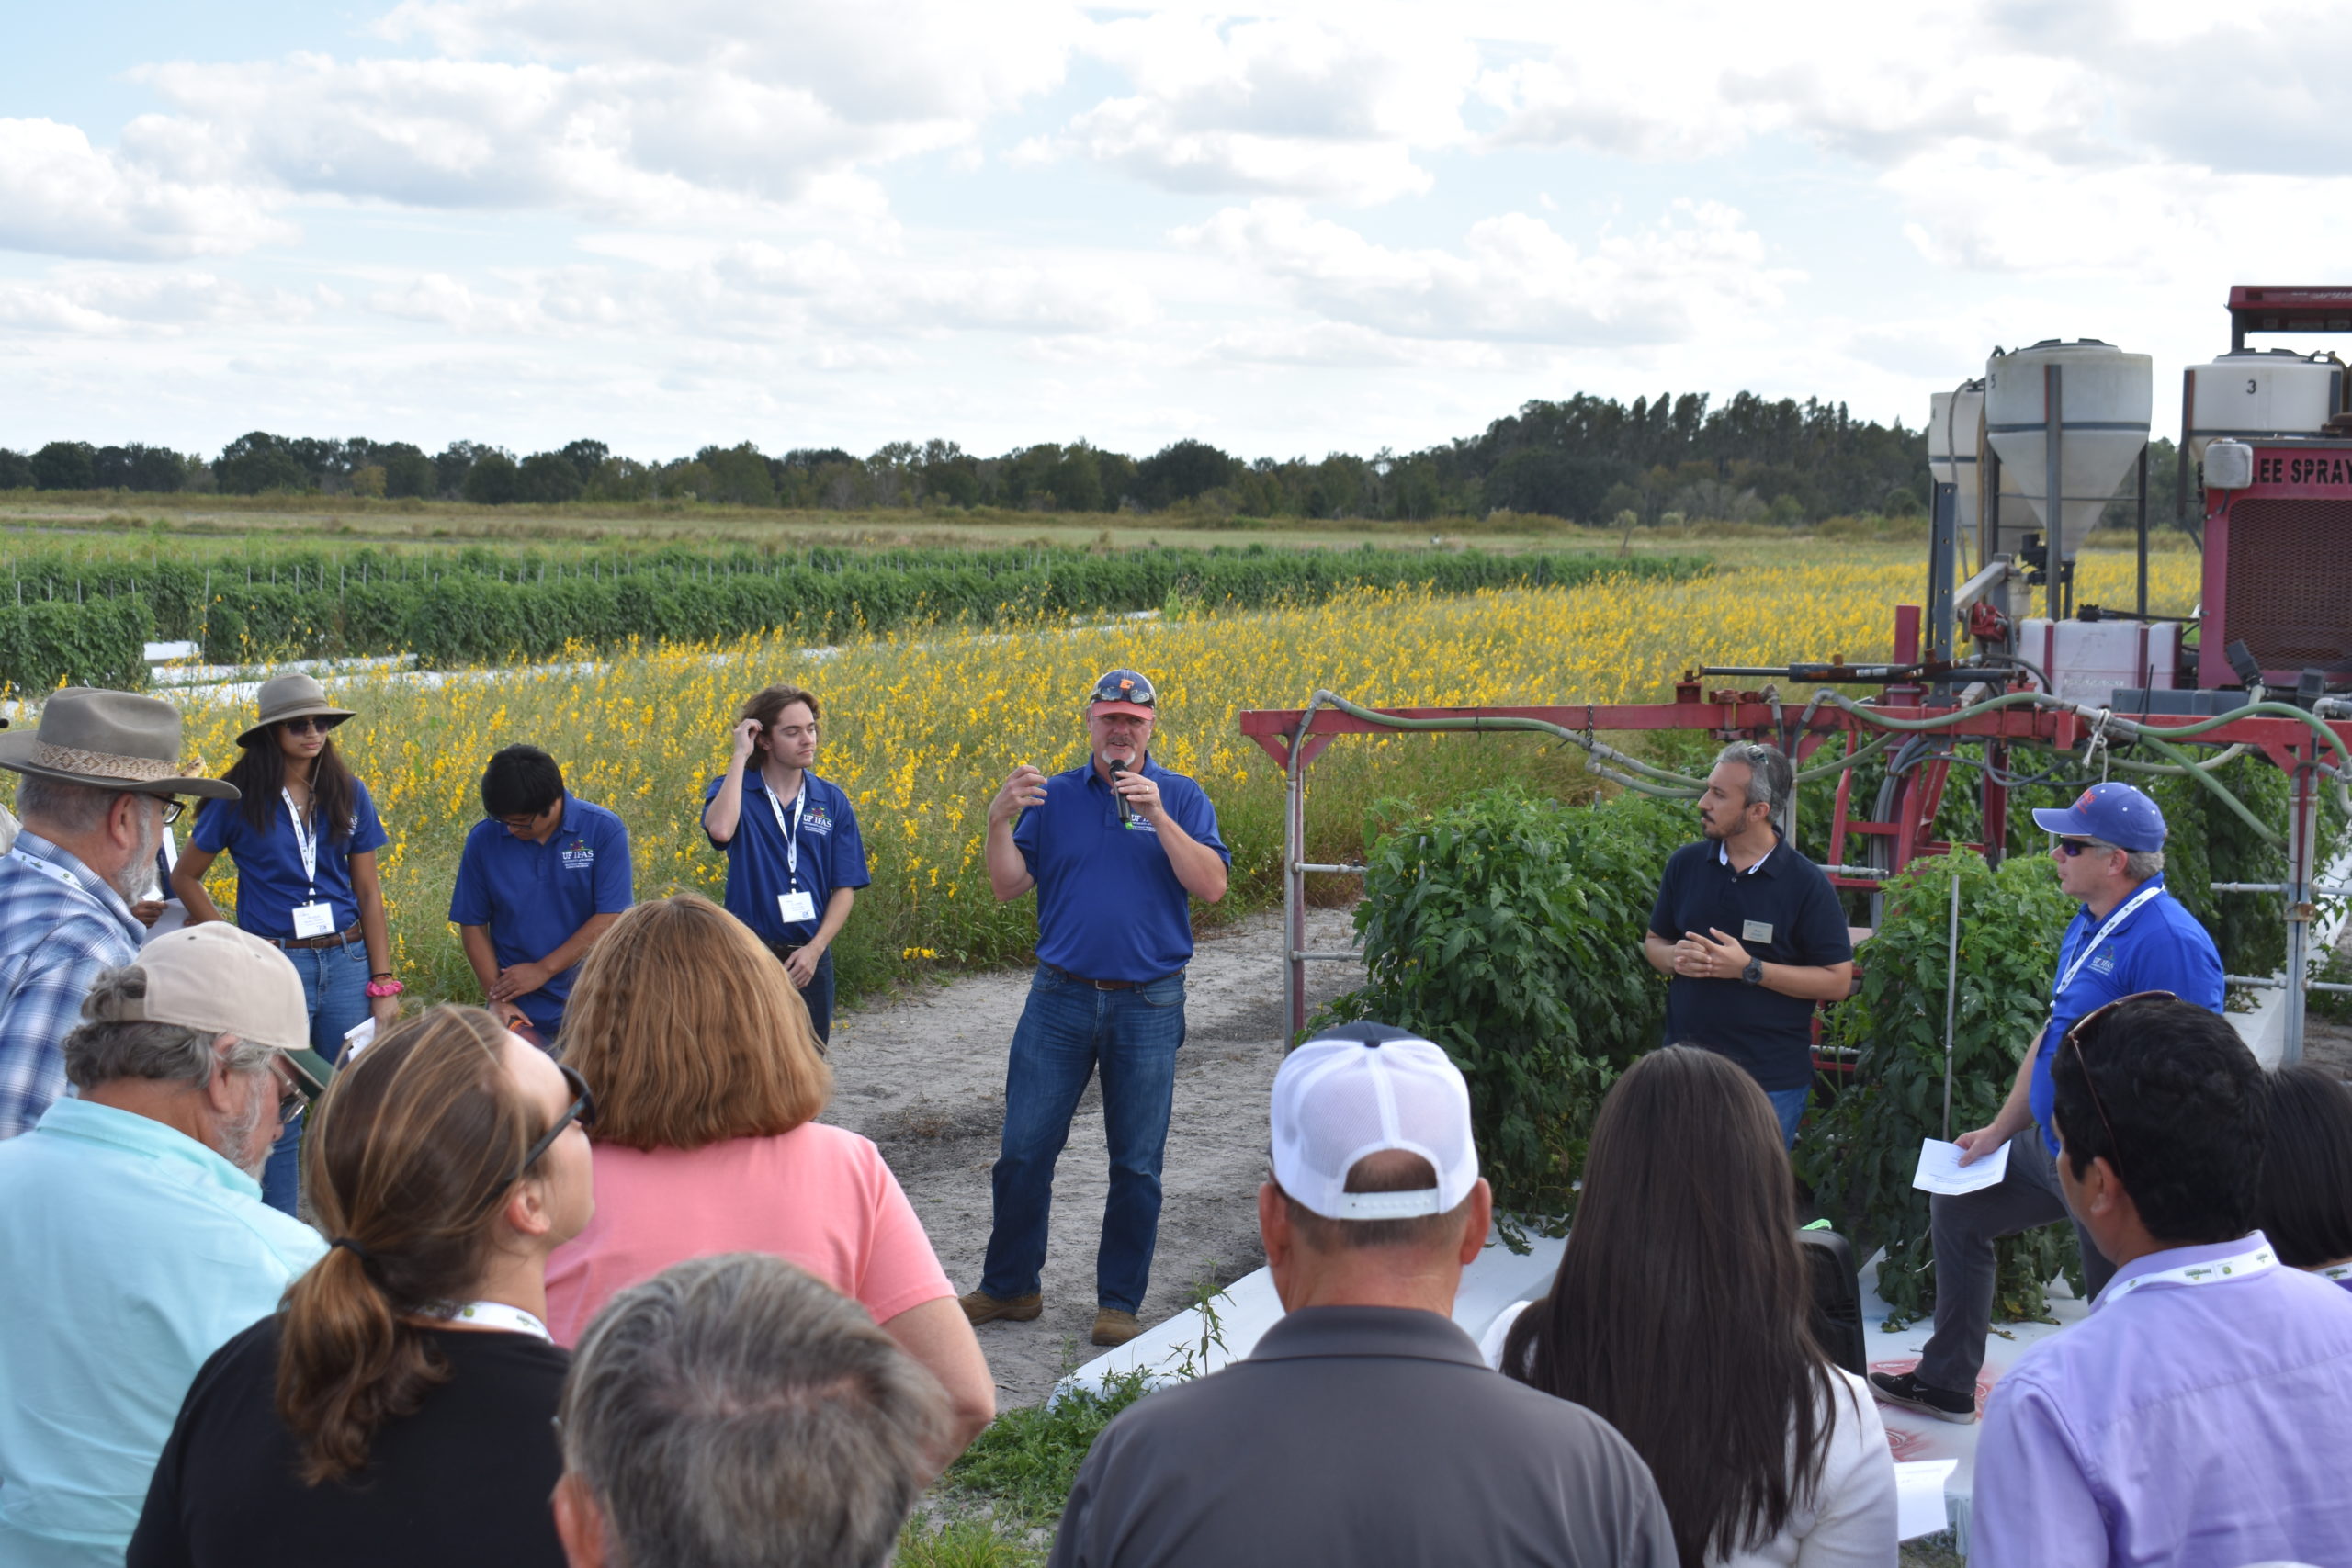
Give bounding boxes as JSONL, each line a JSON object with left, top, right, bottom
{"left": 125, "top": 1006, "right": 595, "bottom": 1568}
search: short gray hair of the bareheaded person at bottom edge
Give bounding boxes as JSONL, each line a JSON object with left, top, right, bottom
{"left": 558, "top": 1253, "right": 950, "bottom": 1568}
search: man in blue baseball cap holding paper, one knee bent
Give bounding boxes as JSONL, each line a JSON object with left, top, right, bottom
{"left": 1870, "top": 783, "right": 2222, "bottom": 1422}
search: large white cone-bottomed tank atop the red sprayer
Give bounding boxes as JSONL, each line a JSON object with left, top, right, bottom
{"left": 1985, "top": 339, "right": 2154, "bottom": 559}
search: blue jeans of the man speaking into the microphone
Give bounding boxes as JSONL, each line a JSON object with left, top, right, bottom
{"left": 981, "top": 964, "right": 1183, "bottom": 1312}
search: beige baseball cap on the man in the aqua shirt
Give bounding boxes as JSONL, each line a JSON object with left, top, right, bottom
{"left": 101, "top": 919, "right": 334, "bottom": 1100}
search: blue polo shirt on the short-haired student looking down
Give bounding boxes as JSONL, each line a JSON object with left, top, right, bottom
{"left": 449, "top": 792, "right": 633, "bottom": 1034}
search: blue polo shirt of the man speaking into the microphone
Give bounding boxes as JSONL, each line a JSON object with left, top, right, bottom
{"left": 1013, "top": 755, "right": 1232, "bottom": 983}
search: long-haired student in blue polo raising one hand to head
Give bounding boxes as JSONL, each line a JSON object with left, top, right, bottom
{"left": 703, "top": 686, "right": 873, "bottom": 1043}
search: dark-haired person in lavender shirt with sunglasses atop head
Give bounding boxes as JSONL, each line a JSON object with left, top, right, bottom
{"left": 1969, "top": 995, "right": 2352, "bottom": 1568}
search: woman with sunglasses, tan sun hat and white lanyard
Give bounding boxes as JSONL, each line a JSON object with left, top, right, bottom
{"left": 172, "top": 674, "right": 400, "bottom": 1213}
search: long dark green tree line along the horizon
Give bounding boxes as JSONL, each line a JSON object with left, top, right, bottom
{"left": 0, "top": 392, "right": 1928, "bottom": 526}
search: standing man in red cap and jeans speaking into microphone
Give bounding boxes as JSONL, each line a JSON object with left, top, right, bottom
{"left": 965, "top": 670, "right": 1232, "bottom": 1345}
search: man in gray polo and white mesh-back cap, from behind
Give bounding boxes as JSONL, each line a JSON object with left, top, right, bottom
{"left": 1051, "top": 1022, "right": 1677, "bottom": 1568}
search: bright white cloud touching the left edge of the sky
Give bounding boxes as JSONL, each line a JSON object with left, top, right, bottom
{"left": 0, "top": 120, "right": 294, "bottom": 259}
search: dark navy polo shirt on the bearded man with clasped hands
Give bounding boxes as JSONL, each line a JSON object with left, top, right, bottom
{"left": 1649, "top": 840, "right": 1853, "bottom": 1090}
